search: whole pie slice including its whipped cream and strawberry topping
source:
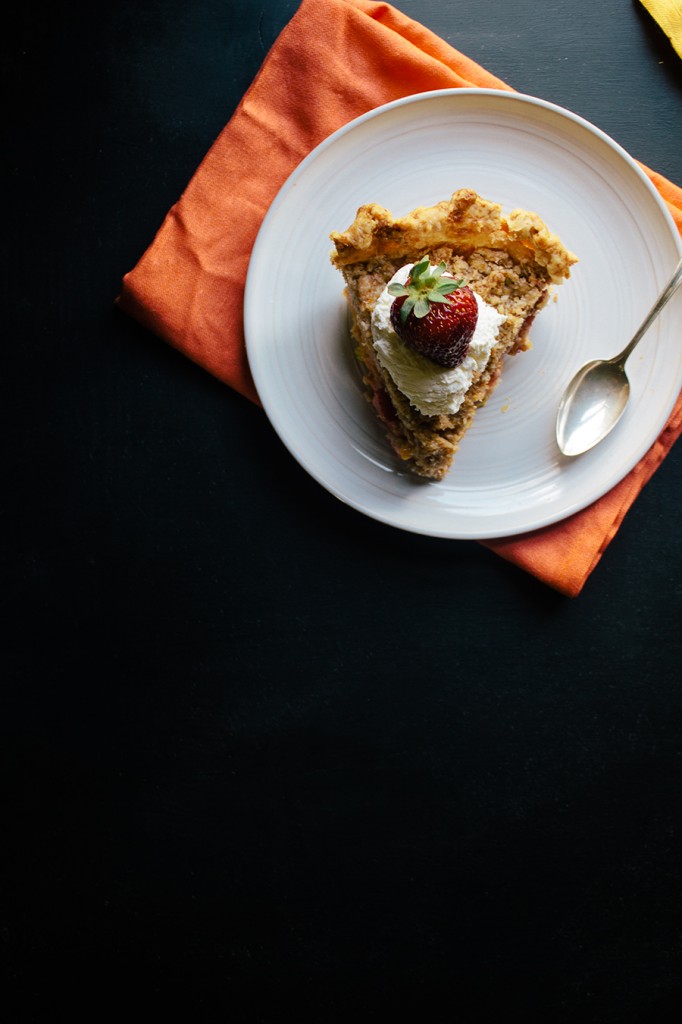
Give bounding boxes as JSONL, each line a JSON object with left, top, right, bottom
{"left": 331, "top": 188, "right": 577, "bottom": 480}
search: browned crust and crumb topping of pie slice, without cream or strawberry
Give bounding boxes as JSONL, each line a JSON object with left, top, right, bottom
{"left": 331, "top": 188, "right": 578, "bottom": 479}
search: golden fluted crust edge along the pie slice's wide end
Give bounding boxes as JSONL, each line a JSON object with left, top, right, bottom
{"left": 330, "top": 188, "right": 578, "bottom": 283}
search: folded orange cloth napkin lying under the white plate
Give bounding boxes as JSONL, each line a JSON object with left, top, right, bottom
{"left": 118, "top": 0, "right": 682, "bottom": 596}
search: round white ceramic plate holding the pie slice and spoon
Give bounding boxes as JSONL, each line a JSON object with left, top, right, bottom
{"left": 245, "top": 89, "right": 682, "bottom": 539}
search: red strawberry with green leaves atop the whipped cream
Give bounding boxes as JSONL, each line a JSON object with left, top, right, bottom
{"left": 388, "top": 256, "right": 478, "bottom": 369}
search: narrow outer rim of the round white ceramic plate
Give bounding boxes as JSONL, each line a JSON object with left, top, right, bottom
{"left": 244, "top": 87, "right": 682, "bottom": 541}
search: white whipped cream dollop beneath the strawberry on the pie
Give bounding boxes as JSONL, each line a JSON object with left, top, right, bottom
{"left": 372, "top": 263, "right": 507, "bottom": 416}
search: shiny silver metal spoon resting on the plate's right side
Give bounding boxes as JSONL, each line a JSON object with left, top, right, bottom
{"left": 556, "top": 259, "right": 682, "bottom": 456}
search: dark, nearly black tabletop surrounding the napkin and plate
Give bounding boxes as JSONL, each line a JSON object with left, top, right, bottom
{"left": 5, "top": 0, "right": 682, "bottom": 1024}
